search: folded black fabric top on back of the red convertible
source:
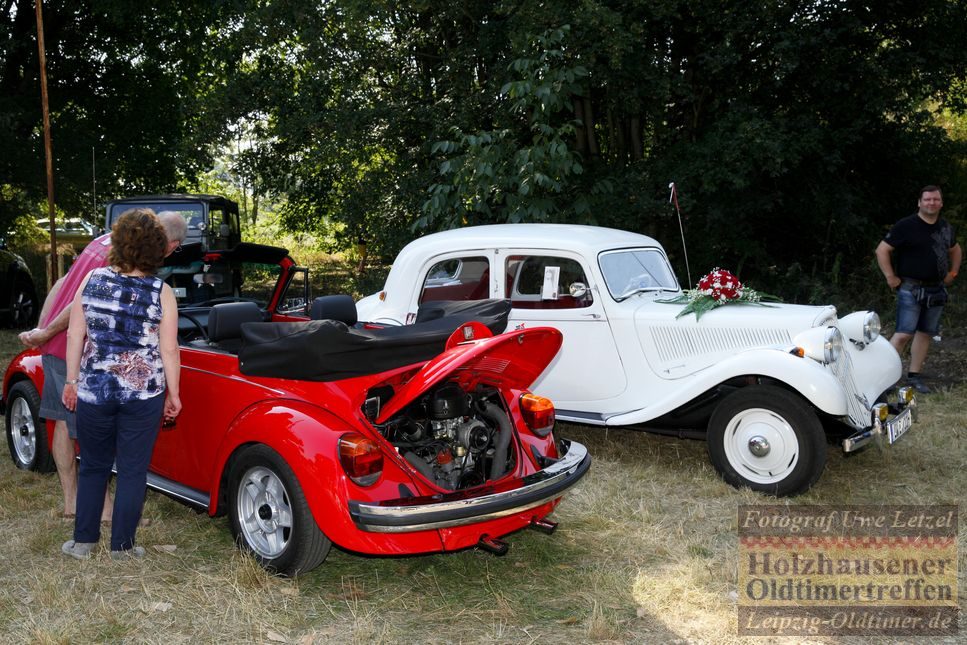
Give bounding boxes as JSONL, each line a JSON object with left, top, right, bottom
{"left": 238, "top": 300, "right": 511, "bottom": 381}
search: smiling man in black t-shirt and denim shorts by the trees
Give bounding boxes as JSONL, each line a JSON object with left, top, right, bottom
{"left": 876, "top": 186, "right": 962, "bottom": 394}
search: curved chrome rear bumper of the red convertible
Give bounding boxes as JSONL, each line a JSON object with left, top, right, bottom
{"left": 349, "top": 440, "right": 591, "bottom": 533}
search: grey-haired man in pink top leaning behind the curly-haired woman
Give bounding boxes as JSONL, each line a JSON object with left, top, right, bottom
{"left": 19, "top": 211, "right": 188, "bottom": 521}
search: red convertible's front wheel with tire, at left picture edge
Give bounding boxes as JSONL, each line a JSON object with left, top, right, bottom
{"left": 7, "top": 381, "right": 54, "bottom": 473}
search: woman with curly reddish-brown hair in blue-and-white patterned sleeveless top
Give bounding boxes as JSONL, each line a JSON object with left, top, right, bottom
{"left": 62, "top": 208, "right": 181, "bottom": 559}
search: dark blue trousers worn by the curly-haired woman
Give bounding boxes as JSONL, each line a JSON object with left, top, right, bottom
{"left": 74, "top": 394, "right": 165, "bottom": 551}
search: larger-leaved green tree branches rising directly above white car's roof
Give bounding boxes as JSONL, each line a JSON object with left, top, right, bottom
{"left": 424, "top": 26, "right": 606, "bottom": 231}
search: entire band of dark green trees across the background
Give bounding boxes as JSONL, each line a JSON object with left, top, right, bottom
{"left": 0, "top": 0, "right": 967, "bottom": 286}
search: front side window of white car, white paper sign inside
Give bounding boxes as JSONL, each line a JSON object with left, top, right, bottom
{"left": 504, "top": 255, "right": 594, "bottom": 309}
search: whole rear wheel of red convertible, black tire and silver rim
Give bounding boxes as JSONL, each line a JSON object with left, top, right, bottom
{"left": 228, "top": 445, "right": 332, "bottom": 576}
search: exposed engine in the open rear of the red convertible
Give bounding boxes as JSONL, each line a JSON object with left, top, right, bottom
{"left": 376, "top": 382, "right": 514, "bottom": 490}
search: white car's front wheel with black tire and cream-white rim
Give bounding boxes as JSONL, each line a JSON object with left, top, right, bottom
{"left": 707, "top": 385, "right": 826, "bottom": 497}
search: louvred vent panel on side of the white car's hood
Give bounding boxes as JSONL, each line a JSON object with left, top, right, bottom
{"left": 651, "top": 326, "right": 791, "bottom": 363}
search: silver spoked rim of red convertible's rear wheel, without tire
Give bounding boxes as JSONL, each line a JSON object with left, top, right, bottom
{"left": 235, "top": 466, "right": 292, "bottom": 560}
